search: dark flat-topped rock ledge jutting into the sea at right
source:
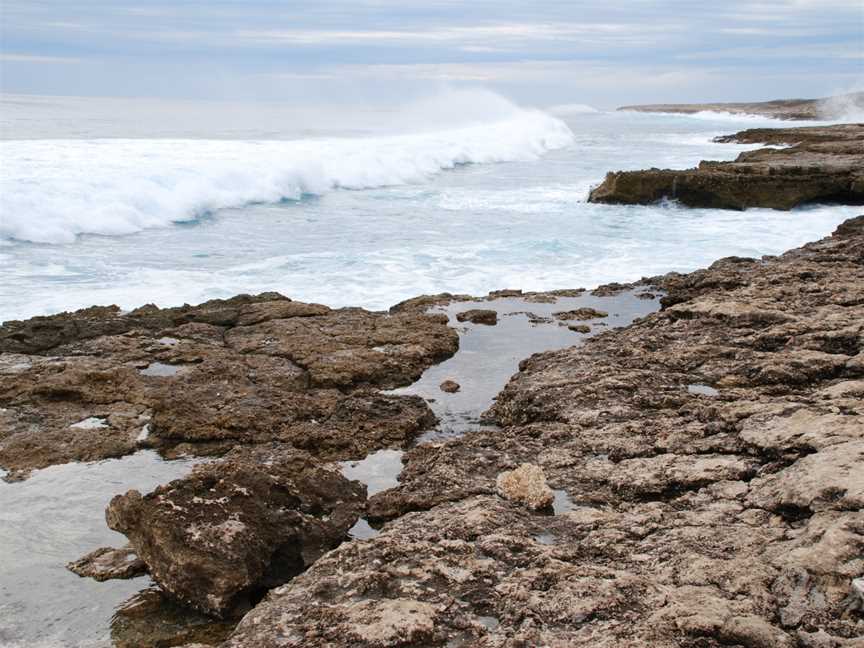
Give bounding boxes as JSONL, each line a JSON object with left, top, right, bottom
{"left": 588, "top": 124, "right": 864, "bottom": 209}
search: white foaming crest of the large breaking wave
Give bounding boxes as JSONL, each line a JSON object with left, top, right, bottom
{"left": 0, "top": 98, "right": 573, "bottom": 243}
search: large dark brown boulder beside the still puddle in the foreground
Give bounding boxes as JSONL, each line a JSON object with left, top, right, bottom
{"left": 106, "top": 444, "right": 366, "bottom": 616}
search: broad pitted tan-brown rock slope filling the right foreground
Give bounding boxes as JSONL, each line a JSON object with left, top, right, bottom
{"left": 224, "top": 217, "right": 864, "bottom": 648}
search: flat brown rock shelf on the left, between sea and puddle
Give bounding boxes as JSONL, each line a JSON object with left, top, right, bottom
{"left": 0, "top": 293, "right": 458, "bottom": 478}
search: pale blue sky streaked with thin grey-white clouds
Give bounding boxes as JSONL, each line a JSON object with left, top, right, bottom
{"left": 0, "top": 0, "right": 864, "bottom": 108}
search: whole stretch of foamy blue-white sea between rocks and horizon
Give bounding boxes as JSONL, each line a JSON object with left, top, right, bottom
{"left": 0, "top": 91, "right": 860, "bottom": 320}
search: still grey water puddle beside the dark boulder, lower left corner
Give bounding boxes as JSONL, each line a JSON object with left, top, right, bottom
{"left": 0, "top": 451, "right": 196, "bottom": 648}
